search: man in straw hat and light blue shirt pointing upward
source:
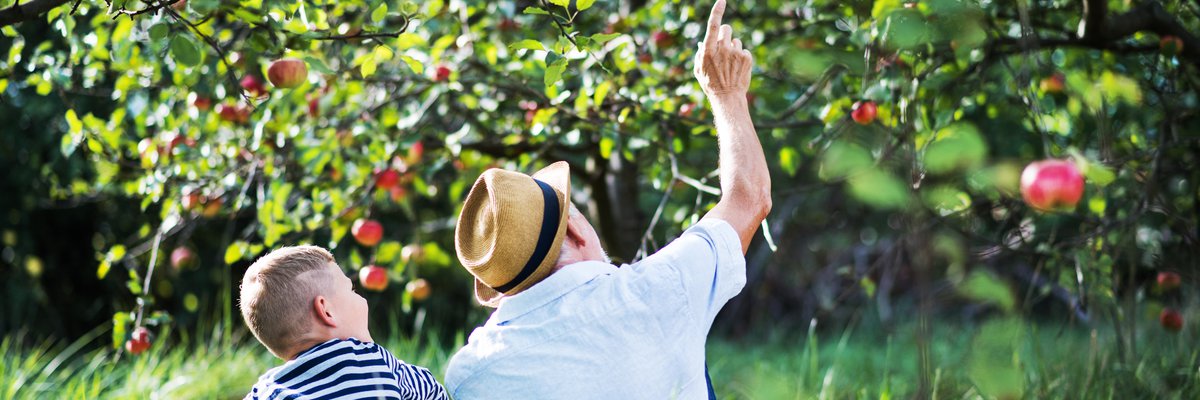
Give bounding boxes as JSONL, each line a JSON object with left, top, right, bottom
{"left": 445, "top": 0, "right": 770, "bottom": 400}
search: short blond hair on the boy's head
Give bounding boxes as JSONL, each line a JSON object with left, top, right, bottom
{"left": 241, "top": 246, "right": 334, "bottom": 358}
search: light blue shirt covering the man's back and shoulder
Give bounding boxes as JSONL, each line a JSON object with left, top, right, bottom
{"left": 445, "top": 220, "right": 745, "bottom": 400}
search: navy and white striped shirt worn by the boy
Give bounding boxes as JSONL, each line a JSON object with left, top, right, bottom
{"left": 246, "top": 338, "right": 449, "bottom": 400}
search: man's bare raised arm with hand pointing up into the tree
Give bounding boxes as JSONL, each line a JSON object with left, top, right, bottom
{"left": 695, "top": 0, "right": 770, "bottom": 253}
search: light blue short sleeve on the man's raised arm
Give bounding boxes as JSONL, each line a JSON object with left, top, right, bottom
{"left": 635, "top": 219, "right": 746, "bottom": 327}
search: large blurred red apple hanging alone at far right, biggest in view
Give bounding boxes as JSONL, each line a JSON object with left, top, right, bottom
{"left": 1021, "top": 160, "right": 1084, "bottom": 211}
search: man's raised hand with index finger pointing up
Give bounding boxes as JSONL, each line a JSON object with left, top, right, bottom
{"left": 695, "top": 0, "right": 754, "bottom": 101}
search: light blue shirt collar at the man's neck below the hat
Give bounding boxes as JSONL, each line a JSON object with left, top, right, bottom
{"left": 490, "top": 261, "right": 617, "bottom": 324}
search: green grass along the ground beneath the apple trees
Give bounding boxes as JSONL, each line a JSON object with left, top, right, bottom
{"left": 0, "top": 323, "right": 1200, "bottom": 400}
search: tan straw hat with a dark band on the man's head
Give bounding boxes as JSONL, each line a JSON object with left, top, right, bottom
{"left": 454, "top": 161, "right": 571, "bottom": 308}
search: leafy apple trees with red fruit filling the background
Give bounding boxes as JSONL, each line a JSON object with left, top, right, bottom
{"left": 0, "top": 0, "right": 1200, "bottom": 360}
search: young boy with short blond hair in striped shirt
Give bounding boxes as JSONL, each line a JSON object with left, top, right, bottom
{"left": 241, "top": 242, "right": 448, "bottom": 400}
